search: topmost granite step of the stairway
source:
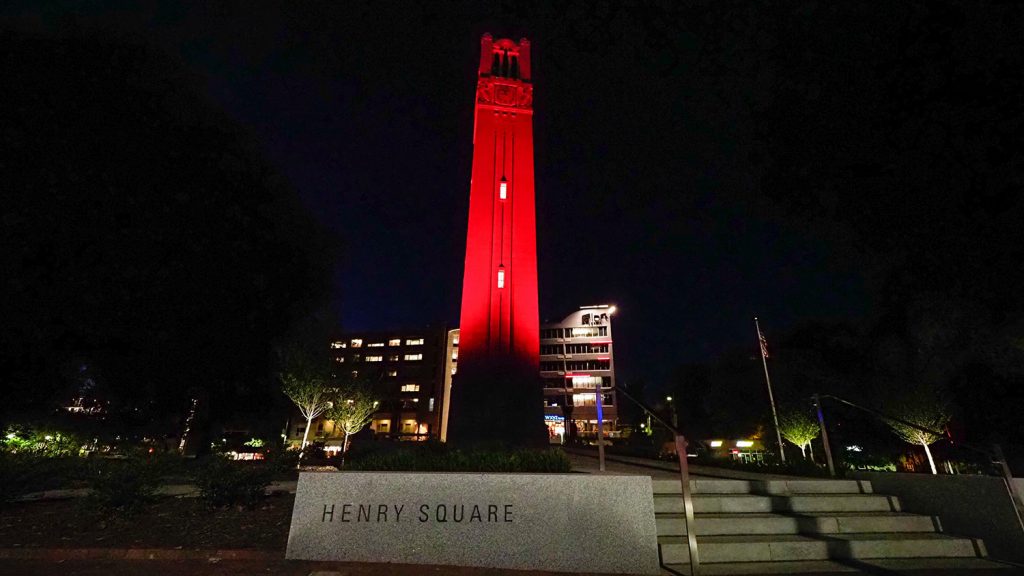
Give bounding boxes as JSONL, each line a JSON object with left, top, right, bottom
{"left": 651, "top": 478, "right": 871, "bottom": 495}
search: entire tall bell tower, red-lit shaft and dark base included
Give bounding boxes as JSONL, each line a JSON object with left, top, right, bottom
{"left": 449, "top": 34, "right": 546, "bottom": 445}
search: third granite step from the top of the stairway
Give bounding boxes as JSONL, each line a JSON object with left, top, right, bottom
{"left": 655, "top": 512, "right": 942, "bottom": 536}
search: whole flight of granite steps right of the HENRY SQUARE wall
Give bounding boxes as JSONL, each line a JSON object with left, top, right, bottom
{"left": 651, "top": 478, "right": 1004, "bottom": 574}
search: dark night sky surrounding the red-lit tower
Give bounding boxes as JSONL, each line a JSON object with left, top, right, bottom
{"left": 9, "top": 2, "right": 867, "bottom": 381}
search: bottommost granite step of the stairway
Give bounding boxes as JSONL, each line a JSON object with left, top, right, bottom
{"left": 665, "top": 558, "right": 1016, "bottom": 576}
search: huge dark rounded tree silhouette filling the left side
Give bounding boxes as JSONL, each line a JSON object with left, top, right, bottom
{"left": 0, "top": 28, "right": 331, "bottom": 431}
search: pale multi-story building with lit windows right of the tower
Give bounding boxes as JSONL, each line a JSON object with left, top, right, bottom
{"left": 541, "top": 304, "right": 618, "bottom": 444}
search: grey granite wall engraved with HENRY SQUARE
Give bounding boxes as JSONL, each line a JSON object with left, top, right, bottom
{"left": 286, "top": 472, "right": 658, "bottom": 574}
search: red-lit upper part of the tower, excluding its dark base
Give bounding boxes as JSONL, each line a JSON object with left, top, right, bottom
{"left": 459, "top": 35, "right": 541, "bottom": 369}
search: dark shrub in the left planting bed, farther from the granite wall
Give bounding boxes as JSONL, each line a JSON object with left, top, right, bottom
{"left": 87, "top": 456, "right": 166, "bottom": 515}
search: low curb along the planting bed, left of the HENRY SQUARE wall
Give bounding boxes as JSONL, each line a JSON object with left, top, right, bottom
{"left": 0, "top": 548, "right": 285, "bottom": 562}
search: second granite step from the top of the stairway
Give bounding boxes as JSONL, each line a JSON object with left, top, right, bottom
{"left": 654, "top": 487, "right": 900, "bottom": 513}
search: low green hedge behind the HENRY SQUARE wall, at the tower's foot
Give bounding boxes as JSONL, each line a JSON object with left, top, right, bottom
{"left": 345, "top": 446, "right": 571, "bottom": 472}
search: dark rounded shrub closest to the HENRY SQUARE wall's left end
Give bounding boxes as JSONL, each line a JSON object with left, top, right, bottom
{"left": 194, "top": 456, "right": 276, "bottom": 507}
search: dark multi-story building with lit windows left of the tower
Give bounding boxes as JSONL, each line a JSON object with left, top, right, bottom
{"left": 288, "top": 326, "right": 450, "bottom": 449}
